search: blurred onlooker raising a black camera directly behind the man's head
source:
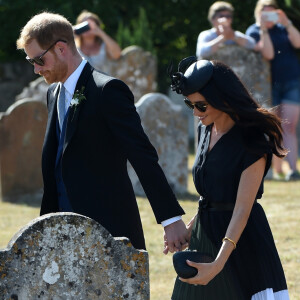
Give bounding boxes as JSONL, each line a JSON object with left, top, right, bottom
{"left": 75, "top": 10, "right": 121, "bottom": 71}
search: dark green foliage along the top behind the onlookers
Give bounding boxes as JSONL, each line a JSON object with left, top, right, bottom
{"left": 0, "top": 0, "right": 300, "bottom": 92}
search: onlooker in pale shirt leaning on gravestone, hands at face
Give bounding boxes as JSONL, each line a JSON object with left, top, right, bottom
{"left": 196, "top": 1, "right": 255, "bottom": 58}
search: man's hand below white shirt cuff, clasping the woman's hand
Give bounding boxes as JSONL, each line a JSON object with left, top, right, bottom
{"left": 163, "top": 220, "right": 188, "bottom": 254}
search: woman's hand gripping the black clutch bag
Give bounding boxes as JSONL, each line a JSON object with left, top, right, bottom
{"left": 179, "top": 260, "right": 223, "bottom": 285}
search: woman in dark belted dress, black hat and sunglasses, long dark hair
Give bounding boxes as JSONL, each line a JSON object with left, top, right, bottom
{"left": 171, "top": 57, "right": 289, "bottom": 300}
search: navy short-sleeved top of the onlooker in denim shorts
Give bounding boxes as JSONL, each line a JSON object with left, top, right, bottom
{"left": 246, "top": 24, "right": 300, "bottom": 84}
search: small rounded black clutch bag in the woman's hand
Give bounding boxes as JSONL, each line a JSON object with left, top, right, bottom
{"left": 173, "top": 251, "right": 214, "bottom": 279}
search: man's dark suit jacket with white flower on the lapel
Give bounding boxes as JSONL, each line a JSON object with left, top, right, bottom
{"left": 41, "top": 63, "right": 184, "bottom": 249}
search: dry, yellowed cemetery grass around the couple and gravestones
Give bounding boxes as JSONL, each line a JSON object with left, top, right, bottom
{"left": 0, "top": 157, "right": 300, "bottom": 300}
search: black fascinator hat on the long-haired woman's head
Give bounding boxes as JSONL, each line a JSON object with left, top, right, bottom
{"left": 168, "top": 56, "right": 214, "bottom": 96}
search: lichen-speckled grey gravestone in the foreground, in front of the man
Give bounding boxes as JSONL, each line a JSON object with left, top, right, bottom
{"left": 0, "top": 213, "right": 150, "bottom": 300}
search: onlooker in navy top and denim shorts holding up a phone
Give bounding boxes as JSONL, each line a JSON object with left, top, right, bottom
{"left": 246, "top": 0, "right": 300, "bottom": 180}
